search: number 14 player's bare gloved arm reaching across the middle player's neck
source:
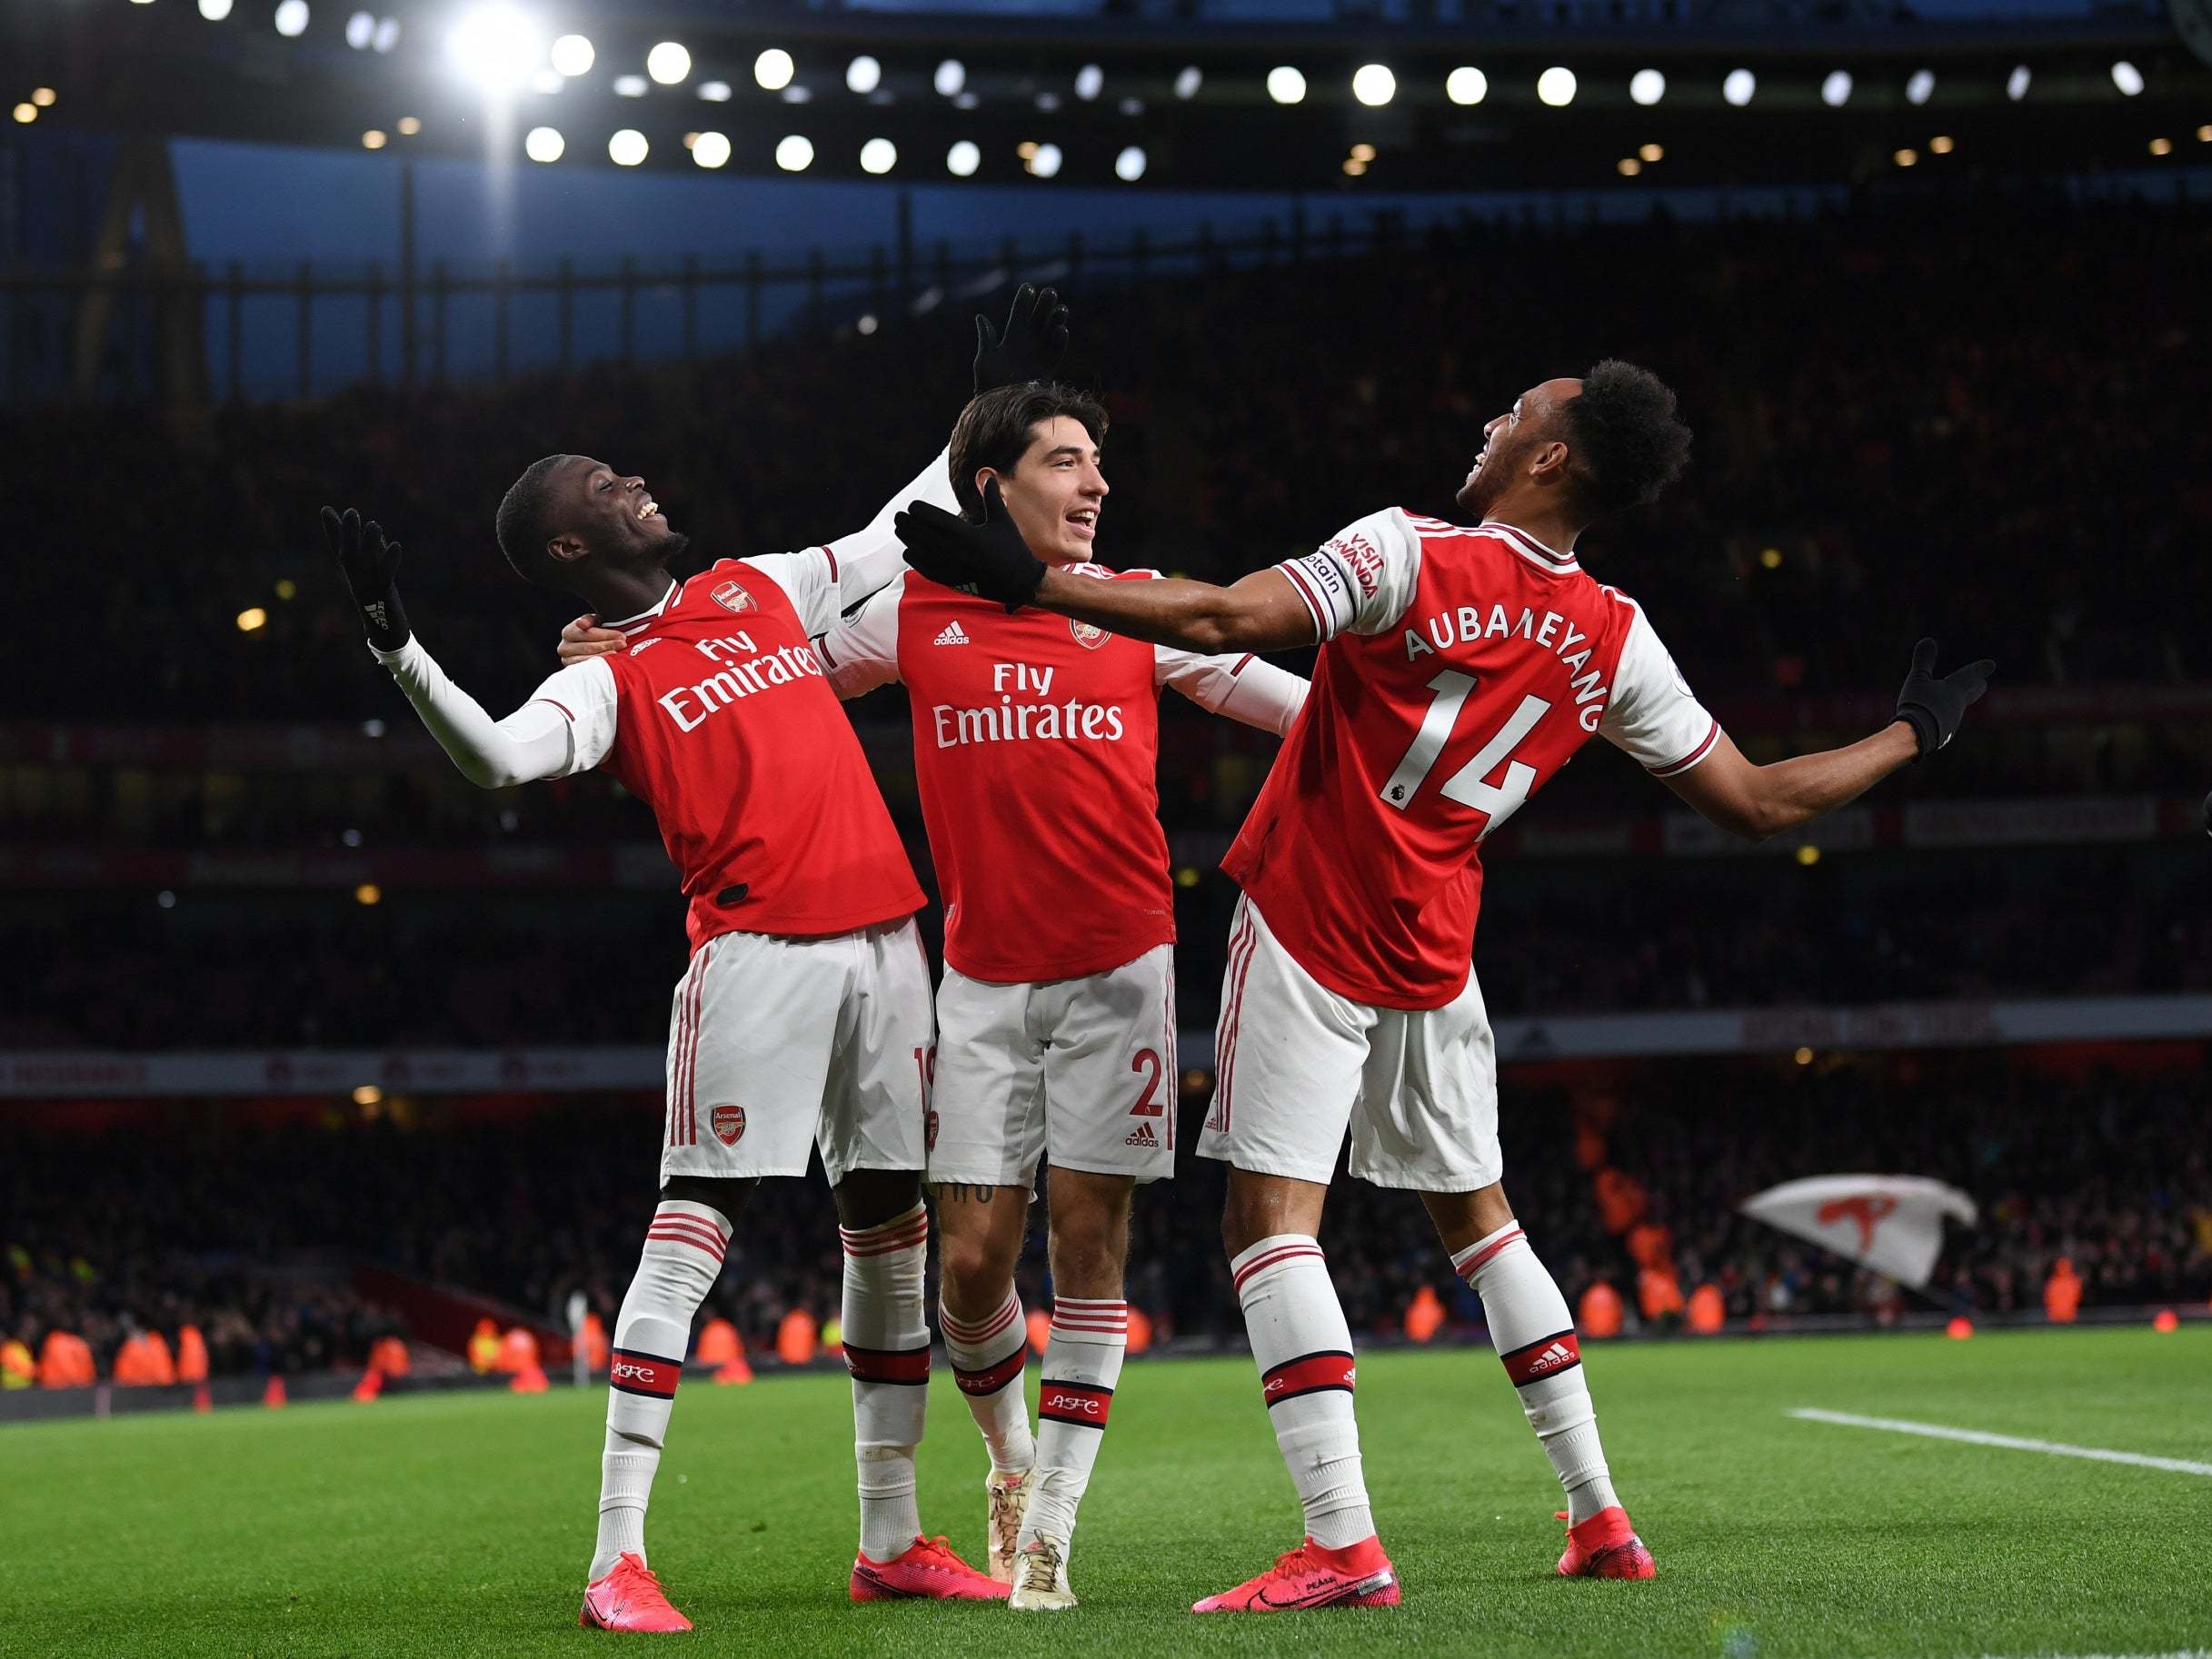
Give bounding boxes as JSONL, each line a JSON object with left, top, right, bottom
{"left": 896, "top": 478, "right": 1314, "bottom": 655}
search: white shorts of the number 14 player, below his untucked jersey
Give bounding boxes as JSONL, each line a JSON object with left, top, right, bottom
{"left": 1199, "top": 898, "right": 1504, "bottom": 1192}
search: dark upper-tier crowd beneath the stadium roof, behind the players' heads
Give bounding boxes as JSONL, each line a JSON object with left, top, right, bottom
{"left": 13, "top": 193, "right": 2212, "bottom": 721}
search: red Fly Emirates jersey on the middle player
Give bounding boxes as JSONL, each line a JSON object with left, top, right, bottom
{"left": 816, "top": 564, "right": 1305, "bottom": 984}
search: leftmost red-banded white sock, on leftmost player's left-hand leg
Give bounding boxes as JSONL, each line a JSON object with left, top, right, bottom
{"left": 586, "top": 1201, "right": 730, "bottom": 1582}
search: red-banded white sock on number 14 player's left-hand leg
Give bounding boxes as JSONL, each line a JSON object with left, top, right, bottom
{"left": 1230, "top": 1232, "right": 1376, "bottom": 1548}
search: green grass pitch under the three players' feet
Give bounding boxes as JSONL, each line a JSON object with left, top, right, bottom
{"left": 0, "top": 1327, "right": 2212, "bottom": 1659}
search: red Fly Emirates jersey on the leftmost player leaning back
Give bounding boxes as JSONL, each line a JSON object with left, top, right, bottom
{"left": 537, "top": 549, "right": 922, "bottom": 949}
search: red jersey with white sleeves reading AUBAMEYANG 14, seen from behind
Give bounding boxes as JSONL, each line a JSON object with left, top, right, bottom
{"left": 1221, "top": 507, "right": 1719, "bottom": 1008}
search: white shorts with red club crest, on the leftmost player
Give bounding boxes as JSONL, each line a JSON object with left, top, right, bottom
{"left": 662, "top": 918, "right": 932, "bottom": 1184}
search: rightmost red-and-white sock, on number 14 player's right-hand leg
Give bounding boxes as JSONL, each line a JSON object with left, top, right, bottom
{"left": 1451, "top": 1221, "right": 1619, "bottom": 1526}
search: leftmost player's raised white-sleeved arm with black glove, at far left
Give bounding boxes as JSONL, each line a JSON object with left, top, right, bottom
{"left": 323, "top": 507, "right": 588, "bottom": 790}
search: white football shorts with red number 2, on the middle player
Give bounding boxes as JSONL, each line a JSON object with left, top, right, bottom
{"left": 929, "top": 945, "right": 1179, "bottom": 1187}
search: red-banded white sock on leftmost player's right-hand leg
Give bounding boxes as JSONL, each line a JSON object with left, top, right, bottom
{"left": 838, "top": 1203, "right": 929, "bottom": 1562}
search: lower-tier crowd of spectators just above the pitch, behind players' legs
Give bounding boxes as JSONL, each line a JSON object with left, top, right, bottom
{"left": 0, "top": 1055, "right": 2212, "bottom": 1371}
